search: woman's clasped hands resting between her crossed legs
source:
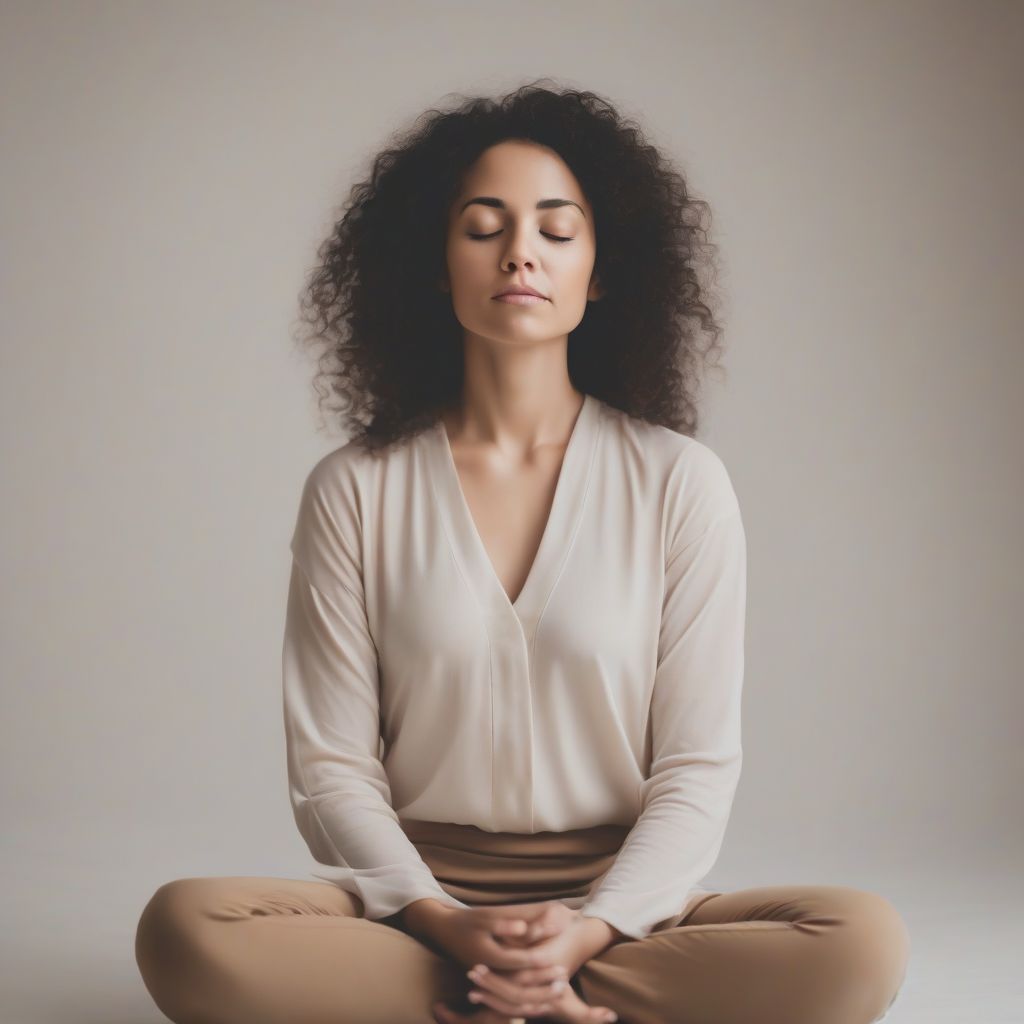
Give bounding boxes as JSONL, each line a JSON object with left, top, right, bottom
{"left": 433, "top": 900, "right": 616, "bottom": 1024}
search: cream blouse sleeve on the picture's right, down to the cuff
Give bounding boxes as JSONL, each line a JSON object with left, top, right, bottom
{"left": 581, "top": 477, "right": 746, "bottom": 939}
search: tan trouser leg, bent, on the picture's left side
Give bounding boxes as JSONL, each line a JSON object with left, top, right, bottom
{"left": 135, "top": 877, "right": 466, "bottom": 1024}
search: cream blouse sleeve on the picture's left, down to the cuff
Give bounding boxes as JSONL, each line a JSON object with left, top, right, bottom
{"left": 282, "top": 470, "right": 466, "bottom": 920}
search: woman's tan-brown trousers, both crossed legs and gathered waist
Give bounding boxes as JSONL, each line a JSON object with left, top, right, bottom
{"left": 135, "top": 820, "right": 910, "bottom": 1024}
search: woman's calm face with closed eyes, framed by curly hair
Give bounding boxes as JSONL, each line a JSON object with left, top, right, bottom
{"left": 445, "top": 140, "right": 600, "bottom": 344}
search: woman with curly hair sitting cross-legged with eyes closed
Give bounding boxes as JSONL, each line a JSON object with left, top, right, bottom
{"left": 136, "top": 83, "right": 909, "bottom": 1024}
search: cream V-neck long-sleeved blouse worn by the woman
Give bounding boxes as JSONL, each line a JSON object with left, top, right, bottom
{"left": 283, "top": 395, "right": 746, "bottom": 938}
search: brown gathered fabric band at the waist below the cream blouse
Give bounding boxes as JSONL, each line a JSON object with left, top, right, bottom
{"left": 400, "top": 818, "right": 630, "bottom": 905}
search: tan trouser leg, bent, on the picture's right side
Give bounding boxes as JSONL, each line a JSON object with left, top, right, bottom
{"left": 574, "top": 885, "right": 910, "bottom": 1024}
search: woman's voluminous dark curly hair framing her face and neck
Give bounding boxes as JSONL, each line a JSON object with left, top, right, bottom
{"left": 298, "top": 79, "right": 722, "bottom": 450}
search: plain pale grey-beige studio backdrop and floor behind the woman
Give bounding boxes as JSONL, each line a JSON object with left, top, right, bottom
{"left": 0, "top": 0, "right": 1024, "bottom": 1024}
